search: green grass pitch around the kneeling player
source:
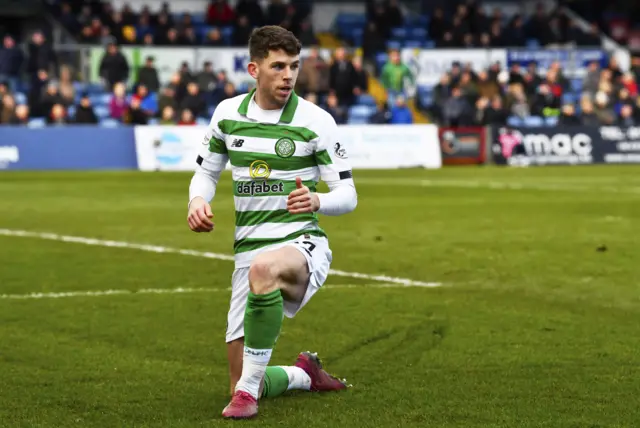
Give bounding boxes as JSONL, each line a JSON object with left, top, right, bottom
{"left": 0, "top": 166, "right": 640, "bottom": 428}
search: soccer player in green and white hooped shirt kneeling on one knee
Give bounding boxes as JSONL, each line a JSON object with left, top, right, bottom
{"left": 187, "top": 26, "right": 357, "bottom": 419}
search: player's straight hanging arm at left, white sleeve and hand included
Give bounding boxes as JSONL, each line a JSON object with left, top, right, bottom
{"left": 187, "top": 105, "right": 229, "bottom": 232}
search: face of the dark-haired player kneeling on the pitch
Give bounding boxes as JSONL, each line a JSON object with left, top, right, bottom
{"left": 249, "top": 50, "right": 300, "bottom": 107}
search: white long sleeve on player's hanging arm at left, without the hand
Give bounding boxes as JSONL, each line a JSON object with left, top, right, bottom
{"left": 189, "top": 105, "right": 229, "bottom": 208}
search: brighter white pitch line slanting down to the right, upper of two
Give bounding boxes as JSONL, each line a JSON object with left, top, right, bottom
{"left": 0, "top": 229, "right": 442, "bottom": 287}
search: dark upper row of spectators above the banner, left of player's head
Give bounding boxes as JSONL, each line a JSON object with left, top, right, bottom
{"left": 47, "top": 0, "right": 316, "bottom": 46}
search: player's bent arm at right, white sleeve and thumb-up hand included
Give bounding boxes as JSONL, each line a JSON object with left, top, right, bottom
{"left": 287, "top": 115, "right": 358, "bottom": 216}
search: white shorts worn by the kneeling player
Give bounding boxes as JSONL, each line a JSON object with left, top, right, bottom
{"left": 226, "top": 235, "right": 332, "bottom": 343}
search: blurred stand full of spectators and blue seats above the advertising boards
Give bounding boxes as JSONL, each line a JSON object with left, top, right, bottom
{"left": 0, "top": 0, "right": 640, "bottom": 127}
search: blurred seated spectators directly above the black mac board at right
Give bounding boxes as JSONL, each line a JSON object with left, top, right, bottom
{"left": 422, "top": 57, "right": 640, "bottom": 126}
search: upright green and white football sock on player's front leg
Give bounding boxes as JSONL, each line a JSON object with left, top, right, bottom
{"left": 236, "top": 290, "right": 283, "bottom": 400}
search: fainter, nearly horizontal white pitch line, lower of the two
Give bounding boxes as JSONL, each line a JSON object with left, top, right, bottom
{"left": 0, "top": 283, "right": 430, "bottom": 300}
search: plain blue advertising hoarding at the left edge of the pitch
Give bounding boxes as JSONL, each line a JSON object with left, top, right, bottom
{"left": 0, "top": 126, "right": 138, "bottom": 170}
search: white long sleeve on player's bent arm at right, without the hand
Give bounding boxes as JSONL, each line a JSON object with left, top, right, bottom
{"left": 315, "top": 114, "right": 358, "bottom": 216}
